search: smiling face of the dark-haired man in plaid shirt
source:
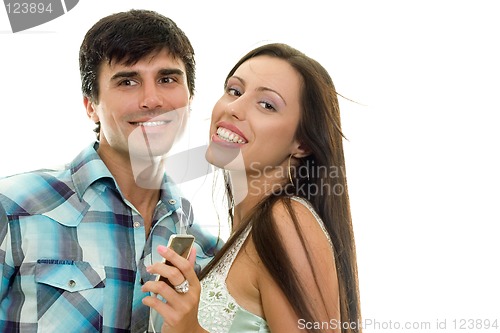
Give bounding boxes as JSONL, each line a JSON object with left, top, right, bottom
{"left": 84, "top": 50, "right": 190, "bottom": 159}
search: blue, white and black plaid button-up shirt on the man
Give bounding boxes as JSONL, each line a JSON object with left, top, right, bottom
{"left": 0, "top": 144, "right": 222, "bottom": 333}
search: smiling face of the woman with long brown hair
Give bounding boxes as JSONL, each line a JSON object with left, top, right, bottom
{"left": 206, "top": 56, "right": 302, "bottom": 175}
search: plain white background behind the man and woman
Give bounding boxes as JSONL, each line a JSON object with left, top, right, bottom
{"left": 0, "top": 0, "right": 500, "bottom": 332}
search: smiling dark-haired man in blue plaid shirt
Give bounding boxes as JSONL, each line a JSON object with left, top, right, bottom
{"left": 0, "top": 10, "right": 221, "bottom": 332}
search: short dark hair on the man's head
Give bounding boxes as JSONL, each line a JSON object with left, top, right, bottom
{"left": 80, "top": 10, "right": 195, "bottom": 103}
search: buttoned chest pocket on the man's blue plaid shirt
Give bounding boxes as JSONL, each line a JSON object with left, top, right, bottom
{"left": 35, "top": 259, "right": 106, "bottom": 332}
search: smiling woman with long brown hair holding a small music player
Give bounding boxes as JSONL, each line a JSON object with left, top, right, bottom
{"left": 144, "top": 44, "right": 361, "bottom": 332}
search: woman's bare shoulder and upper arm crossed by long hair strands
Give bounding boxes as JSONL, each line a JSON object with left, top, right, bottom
{"left": 258, "top": 200, "right": 340, "bottom": 333}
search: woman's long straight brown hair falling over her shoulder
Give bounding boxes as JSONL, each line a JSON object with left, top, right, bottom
{"left": 200, "top": 43, "right": 361, "bottom": 333}
